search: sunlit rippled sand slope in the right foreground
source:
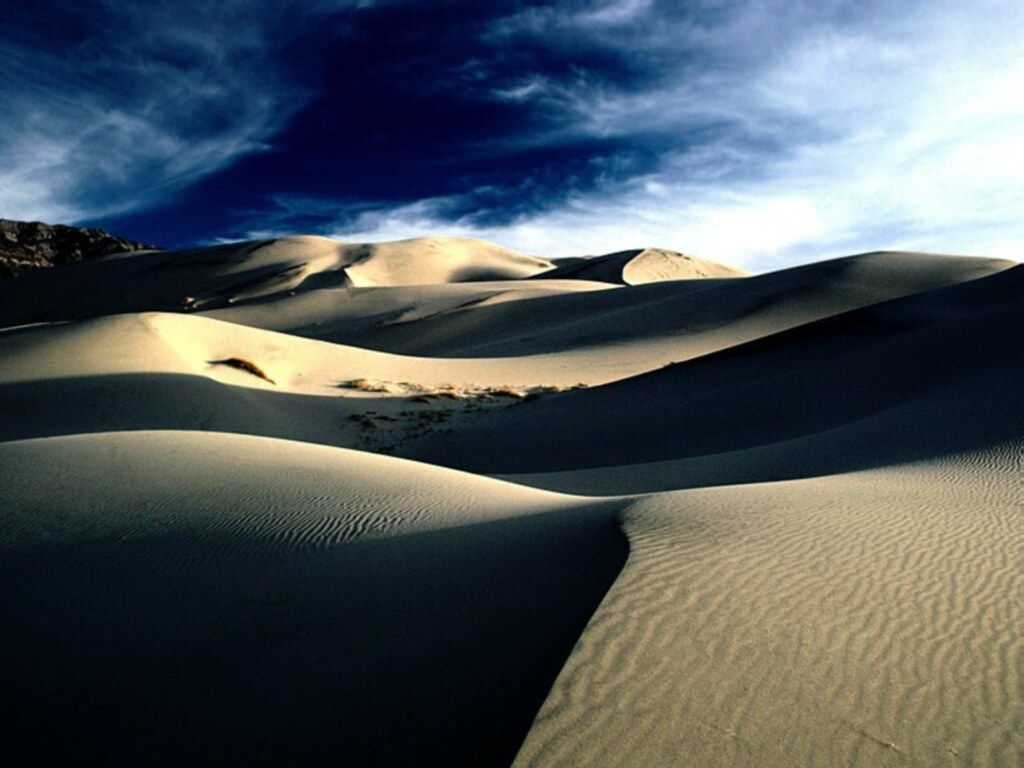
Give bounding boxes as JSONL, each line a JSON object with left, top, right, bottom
{"left": 516, "top": 441, "right": 1024, "bottom": 768}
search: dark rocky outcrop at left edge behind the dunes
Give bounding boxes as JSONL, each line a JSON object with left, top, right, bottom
{"left": 0, "top": 219, "right": 160, "bottom": 279}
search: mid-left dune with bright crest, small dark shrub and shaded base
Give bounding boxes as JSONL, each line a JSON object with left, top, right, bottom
{"left": 0, "top": 312, "right": 598, "bottom": 450}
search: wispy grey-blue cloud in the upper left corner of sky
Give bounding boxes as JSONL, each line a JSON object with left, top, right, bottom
{"left": 0, "top": 0, "right": 360, "bottom": 221}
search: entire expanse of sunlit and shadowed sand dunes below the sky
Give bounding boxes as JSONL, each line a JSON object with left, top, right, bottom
{"left": 0, "top": 237, "right": 1024, "bottom": 768}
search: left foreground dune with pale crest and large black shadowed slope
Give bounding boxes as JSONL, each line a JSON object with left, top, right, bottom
{"left": 0, "top": 432, "right": 626, "bottom": 765}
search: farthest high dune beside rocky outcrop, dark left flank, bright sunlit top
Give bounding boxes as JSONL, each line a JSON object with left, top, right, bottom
{"left": 0, "top": 237, "right": 552, "bottom": 327}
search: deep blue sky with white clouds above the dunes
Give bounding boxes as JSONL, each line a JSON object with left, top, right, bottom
{"left": 0, "top": 0, "right": 1024, "bottom": 270}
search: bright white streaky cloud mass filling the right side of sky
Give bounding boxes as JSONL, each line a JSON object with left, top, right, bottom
{"left": 317, "top": 3, "right": 1024, "bottom": 268}
